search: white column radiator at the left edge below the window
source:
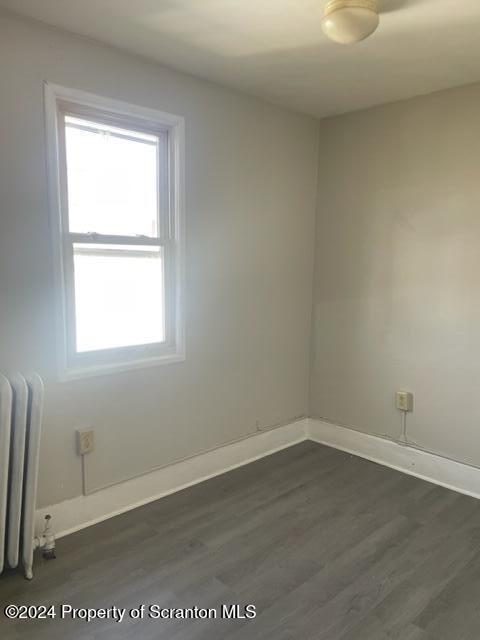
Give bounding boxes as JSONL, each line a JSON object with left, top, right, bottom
{"left": 0, "top": 374, "right": 43, "bottom": 579}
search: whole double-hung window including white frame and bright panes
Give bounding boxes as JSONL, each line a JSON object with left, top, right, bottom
{"left": 46, "top": 84, "right": 184, "bottom": 378}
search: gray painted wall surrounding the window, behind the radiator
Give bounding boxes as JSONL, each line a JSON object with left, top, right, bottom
{"left": 0, "top": 14, "right": 318, "bottom": 506}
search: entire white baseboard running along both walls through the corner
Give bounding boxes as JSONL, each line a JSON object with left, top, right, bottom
{"left": 35, "top": 418, "right": 480, "bottom": 538}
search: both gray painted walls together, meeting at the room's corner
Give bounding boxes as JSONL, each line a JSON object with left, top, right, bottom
{"left": 0, "top": 6, "right": 480, "bottom": 506}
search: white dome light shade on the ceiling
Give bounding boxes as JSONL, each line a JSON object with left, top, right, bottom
{"left": 322, "top": 0, "right": 379, "bottom": 44}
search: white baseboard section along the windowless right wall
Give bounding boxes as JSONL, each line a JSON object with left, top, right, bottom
{"left": 307, "top": 418, "right": 480, "bottom": 498}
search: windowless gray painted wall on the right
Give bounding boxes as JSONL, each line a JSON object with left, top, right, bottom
{"left": 310, "top": 84, "right": 480, "bottom": 465}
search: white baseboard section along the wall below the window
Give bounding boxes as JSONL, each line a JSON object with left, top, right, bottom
{"left": 35, "top": 419, "right": 307, "bottom": 538}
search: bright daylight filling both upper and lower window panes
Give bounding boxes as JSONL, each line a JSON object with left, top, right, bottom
{"left": 65, "top": 116, "right": 165, "bottom": 352}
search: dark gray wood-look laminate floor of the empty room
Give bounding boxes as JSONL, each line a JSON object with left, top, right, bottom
{"left": 0, "top": 442, "right": 480, "bottom": 640}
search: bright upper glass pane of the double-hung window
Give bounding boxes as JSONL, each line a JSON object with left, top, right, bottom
{"left": 65, "top": 116, "right": 158, "bottom": 236}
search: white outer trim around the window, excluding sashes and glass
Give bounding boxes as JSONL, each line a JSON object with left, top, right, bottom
{"left": 44, "top": 82, "right": 185, "bottom": 381}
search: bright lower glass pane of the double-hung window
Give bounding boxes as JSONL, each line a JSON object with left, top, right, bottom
{"left": 74, "top": 244, "right": 165, "bottom": 352}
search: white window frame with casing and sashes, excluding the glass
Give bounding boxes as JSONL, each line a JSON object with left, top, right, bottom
{"left": 44, "top": 82, "right": 185, "bottom": 380}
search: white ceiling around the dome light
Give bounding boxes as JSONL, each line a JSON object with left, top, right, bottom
{"left": 0, "top": 0, "right": 480, "bottom": 116}
